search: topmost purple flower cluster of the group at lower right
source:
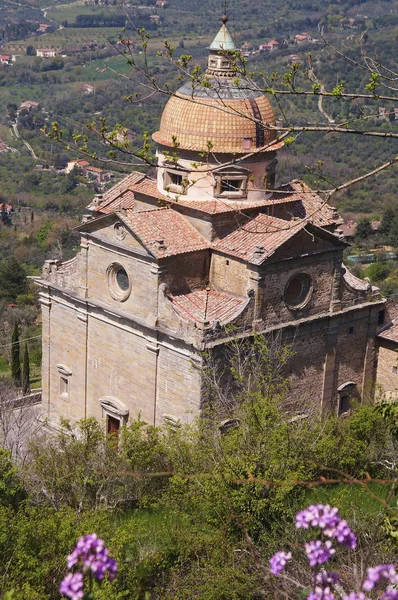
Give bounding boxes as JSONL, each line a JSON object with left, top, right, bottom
{"left": 296, "top": 504, "right": 357, "bottom": 550}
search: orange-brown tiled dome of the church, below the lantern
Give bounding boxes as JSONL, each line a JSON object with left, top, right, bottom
{"left": 153, "top": 79, "right": 276, "bottom": 154}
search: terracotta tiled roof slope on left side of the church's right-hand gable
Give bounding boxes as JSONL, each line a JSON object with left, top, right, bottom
{"left": 213, "top": 214, "right": 306, "bottom": 264}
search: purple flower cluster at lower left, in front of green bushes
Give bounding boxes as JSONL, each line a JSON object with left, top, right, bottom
{"left": 59, "top": 533, "right": 117, "bottom": 600}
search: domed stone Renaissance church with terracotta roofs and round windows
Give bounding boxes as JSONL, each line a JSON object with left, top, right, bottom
{"left": 37, "top": 17, "right": 385, "bottom": 432}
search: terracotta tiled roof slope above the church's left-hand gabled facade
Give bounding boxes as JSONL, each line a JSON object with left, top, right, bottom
{"left": 117, "top": 208, "right": 209, "bottom": 258}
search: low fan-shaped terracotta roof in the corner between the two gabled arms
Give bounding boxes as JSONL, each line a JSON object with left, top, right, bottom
{"left": 170, "top": 290, "right": 247, "bottom": 323}
